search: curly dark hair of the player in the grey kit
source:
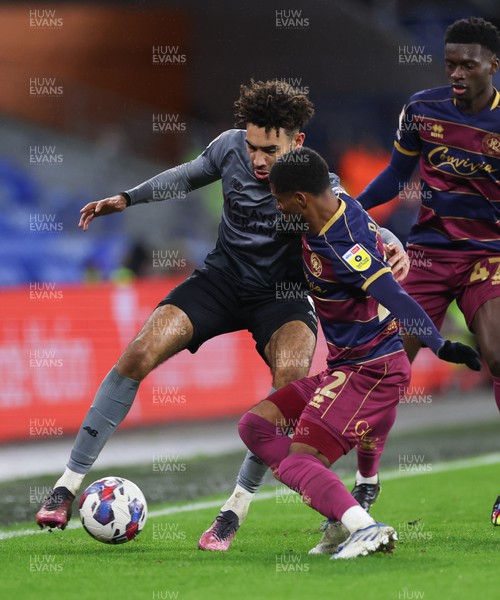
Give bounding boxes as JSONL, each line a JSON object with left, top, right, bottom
{"left": 234, "top": 79, "right": 314, "bottom": 135}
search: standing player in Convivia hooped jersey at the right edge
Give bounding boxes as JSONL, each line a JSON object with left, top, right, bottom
{"left": 358, "top": 17, "right": 500, "bottom": 525}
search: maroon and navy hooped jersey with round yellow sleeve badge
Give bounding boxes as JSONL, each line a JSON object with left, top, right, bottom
{"left": 302, "top": 192, "right": 402, "bottom": 367}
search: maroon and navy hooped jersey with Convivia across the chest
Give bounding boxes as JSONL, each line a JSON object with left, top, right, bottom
{"left": 394, "top": 86, "right": 500, "bottom": 253}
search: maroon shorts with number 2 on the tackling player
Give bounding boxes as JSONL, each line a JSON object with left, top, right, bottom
{"left": 267, "top": 350, "right": 411, "bottom": 462}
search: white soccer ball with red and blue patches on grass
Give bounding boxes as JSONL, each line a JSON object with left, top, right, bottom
{"left": 79, "top": 477, "right": 148, "bottom": 544}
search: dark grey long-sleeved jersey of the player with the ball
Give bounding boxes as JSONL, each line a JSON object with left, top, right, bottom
{"left": 125, "top": 129, "right": 399, "bottom": 291}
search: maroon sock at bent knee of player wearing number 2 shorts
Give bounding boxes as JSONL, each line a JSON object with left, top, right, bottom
{"left": 238, "top": 413, "right": 292, "bottom": 469}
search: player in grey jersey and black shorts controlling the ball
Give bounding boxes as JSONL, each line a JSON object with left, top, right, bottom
{"left": 36, "top": 81, "right": 407, "bottom": 550}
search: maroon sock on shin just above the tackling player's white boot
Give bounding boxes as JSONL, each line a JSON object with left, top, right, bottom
{"left": 278, "top": 454, "right": 359, "bottom": 521}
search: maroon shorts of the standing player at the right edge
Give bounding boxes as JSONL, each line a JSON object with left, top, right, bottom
{"left": 402, "top": 246, "right": 500, "bottom": 331}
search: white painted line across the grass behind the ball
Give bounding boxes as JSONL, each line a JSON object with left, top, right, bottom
{"left": 0, "top": 452, "right": 500, "bottom": 540}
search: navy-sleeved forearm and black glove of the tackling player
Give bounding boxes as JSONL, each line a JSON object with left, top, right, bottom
{"left": 365, "top": 272, "right": 481, "bottom": 371}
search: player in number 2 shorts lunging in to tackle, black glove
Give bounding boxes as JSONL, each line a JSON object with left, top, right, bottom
{"left": 239, "top": 147, "right": 481, "bottom": 559}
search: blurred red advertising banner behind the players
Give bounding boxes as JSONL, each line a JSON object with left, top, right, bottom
{"left": 0, "top": 279, "right": 468, "bottom": 442}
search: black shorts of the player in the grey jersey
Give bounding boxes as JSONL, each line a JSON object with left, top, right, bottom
{"left": 158, "top": 269, "right": 318, "bottom": 363}
